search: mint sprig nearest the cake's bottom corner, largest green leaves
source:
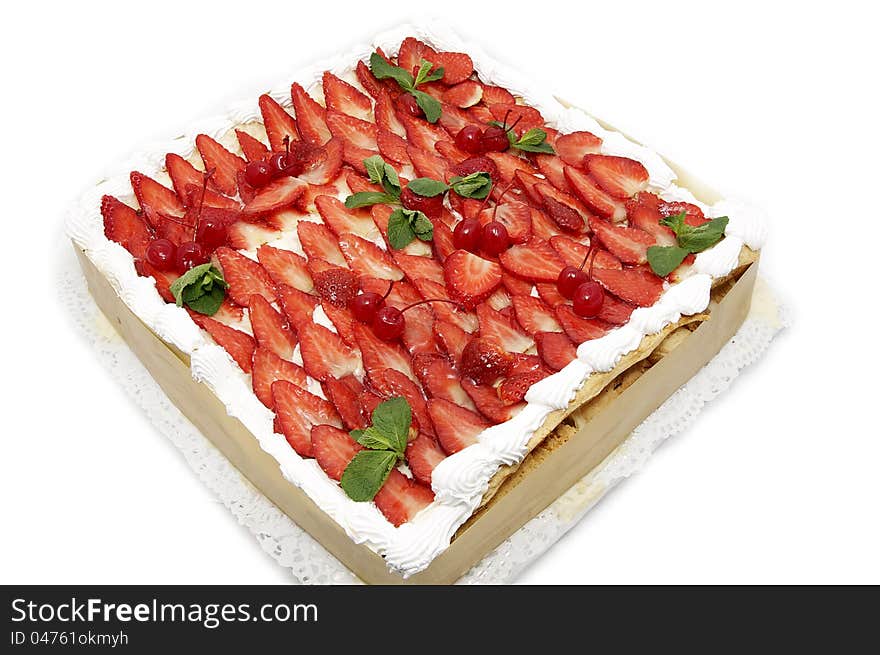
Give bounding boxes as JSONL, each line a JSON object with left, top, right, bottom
{"left": 339, "top": 396, "right": 412, "bottom": 502}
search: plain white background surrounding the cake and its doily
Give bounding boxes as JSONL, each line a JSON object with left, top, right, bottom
{"left": 0, "top": 0, "right": 880, "bottom": 584}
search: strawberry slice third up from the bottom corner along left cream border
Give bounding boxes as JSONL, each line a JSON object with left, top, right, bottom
{"left": 272, "top": 380, "right": 351, "bottom": 458}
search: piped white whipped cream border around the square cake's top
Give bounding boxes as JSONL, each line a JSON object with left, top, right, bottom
{"left": 66, "top": 21, "right": 766, "bottom": 577}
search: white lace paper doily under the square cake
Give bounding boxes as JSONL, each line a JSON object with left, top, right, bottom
{"left": 59, "top": 247, "right": 788, "bottom": 584}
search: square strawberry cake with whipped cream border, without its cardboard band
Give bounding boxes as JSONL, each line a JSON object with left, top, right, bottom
{"left": 69, "top": 26, "right": 764, "bottom": 577}
